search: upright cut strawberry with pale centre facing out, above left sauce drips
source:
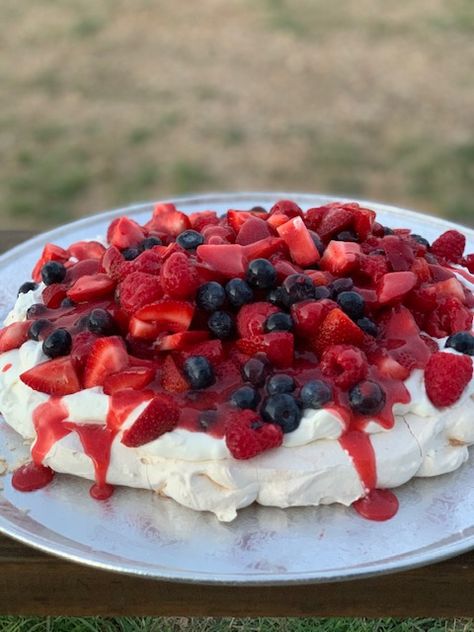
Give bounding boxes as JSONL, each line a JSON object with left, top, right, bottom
{"left": 84, "top": 336, "right": 129, "bottom": 388}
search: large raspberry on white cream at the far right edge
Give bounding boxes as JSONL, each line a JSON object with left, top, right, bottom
{"left": 425, "top": 351, "right": 472, "bottom": 408}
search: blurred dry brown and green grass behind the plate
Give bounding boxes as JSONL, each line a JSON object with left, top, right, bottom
{"left": 0, "top": 0, "right": 474, "bottom": 229}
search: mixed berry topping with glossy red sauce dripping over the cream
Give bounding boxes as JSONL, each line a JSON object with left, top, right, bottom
{"left": 0, "top": 201, "right": 474, "bottom": 520}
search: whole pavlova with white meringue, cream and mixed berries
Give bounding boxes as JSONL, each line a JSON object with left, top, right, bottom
{"left": 0, "top": 200, "right": 474, "bottom": 521}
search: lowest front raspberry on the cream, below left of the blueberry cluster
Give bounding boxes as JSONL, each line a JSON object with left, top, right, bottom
{"left": 225, "top": 410, "right": 283, "bottom": 460}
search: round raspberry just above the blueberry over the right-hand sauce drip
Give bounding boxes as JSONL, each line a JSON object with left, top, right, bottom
{"left": 320, "top": 345, "right": 368, "bottom": 389}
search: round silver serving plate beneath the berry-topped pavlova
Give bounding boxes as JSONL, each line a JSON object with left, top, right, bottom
{"left": 0, "top": 192, "right": 474, "bottom": 585}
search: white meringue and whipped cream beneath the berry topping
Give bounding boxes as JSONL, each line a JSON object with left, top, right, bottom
{"left": 0, "top": 288, "right": 474, "bottom": 521}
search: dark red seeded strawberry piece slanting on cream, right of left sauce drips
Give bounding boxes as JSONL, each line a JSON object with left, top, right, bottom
{"left": 122, "top": 393, "right": 180, "bottom": 448}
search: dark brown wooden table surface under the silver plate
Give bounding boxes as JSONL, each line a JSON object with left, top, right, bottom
{"left": 0, "top": 231, "right": 474, "bottom": 617}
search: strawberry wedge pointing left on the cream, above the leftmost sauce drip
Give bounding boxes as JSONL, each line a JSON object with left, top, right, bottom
{"left": 20, "top": 356, "right": 82, "bottom": 396}
